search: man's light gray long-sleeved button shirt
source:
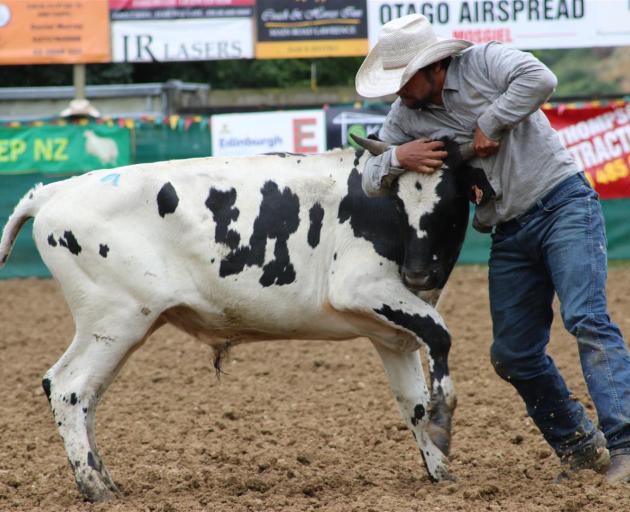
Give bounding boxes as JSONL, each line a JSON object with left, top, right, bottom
{"left": 363, "top": 43, "right": 579, "bottom": 227}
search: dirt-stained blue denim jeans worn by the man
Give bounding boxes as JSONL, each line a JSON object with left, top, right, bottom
{"left": 489, "top": 173, "right": 630, "bottom": 456}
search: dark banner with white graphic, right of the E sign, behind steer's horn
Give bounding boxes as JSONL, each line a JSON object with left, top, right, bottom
{"left": 326, "top": 106, "right": 389, "bottom": 149}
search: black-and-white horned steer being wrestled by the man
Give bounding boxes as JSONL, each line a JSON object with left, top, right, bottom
{"left": 0, "top": 136, "right": 492, "bottom": 501}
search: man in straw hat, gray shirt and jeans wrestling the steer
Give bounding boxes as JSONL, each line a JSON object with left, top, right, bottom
{"left": 356, "top": 14, "right": 630, "bottom": 483}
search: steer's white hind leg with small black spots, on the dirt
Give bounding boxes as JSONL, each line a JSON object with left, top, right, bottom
{"left": 43, "top": 308, "right": 156, "bottom": 501}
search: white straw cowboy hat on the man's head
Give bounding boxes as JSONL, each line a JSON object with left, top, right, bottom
{"left": 355, "top": 14, "right": 472, "bottom": 98}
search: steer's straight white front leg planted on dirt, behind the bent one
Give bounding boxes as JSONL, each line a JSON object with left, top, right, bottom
{"left": 373, "top": 341, "right": 452, "bottom": 481}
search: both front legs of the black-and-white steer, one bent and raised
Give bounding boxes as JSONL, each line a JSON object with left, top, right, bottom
{"left": 330, "top": 271, "right": 456, "bottom": 480}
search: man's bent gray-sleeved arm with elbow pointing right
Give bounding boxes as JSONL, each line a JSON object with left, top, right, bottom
{"left": 475, "top": 43, "right": 558, "bottom": 143}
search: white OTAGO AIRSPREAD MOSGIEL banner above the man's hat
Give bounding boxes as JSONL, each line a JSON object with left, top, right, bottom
{"left": 368, "top": 0, "right": 630, "bottom": 50}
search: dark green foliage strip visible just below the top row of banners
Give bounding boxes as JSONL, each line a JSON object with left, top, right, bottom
{"left": 0, "top": 48, "right": 630, "bottom": 97}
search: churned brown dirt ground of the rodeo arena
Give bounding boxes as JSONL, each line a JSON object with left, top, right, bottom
{"left": 0, "top": 267, "right": 630, "bottom": 512}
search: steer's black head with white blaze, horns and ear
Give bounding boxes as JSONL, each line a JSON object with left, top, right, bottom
{"left": 357, "top": 139, "right": 494, "bottom": 291}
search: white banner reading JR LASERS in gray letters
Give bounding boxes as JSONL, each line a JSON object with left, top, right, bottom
{"left": 111, "top": 18, "right": 254, "bottom": 62}
